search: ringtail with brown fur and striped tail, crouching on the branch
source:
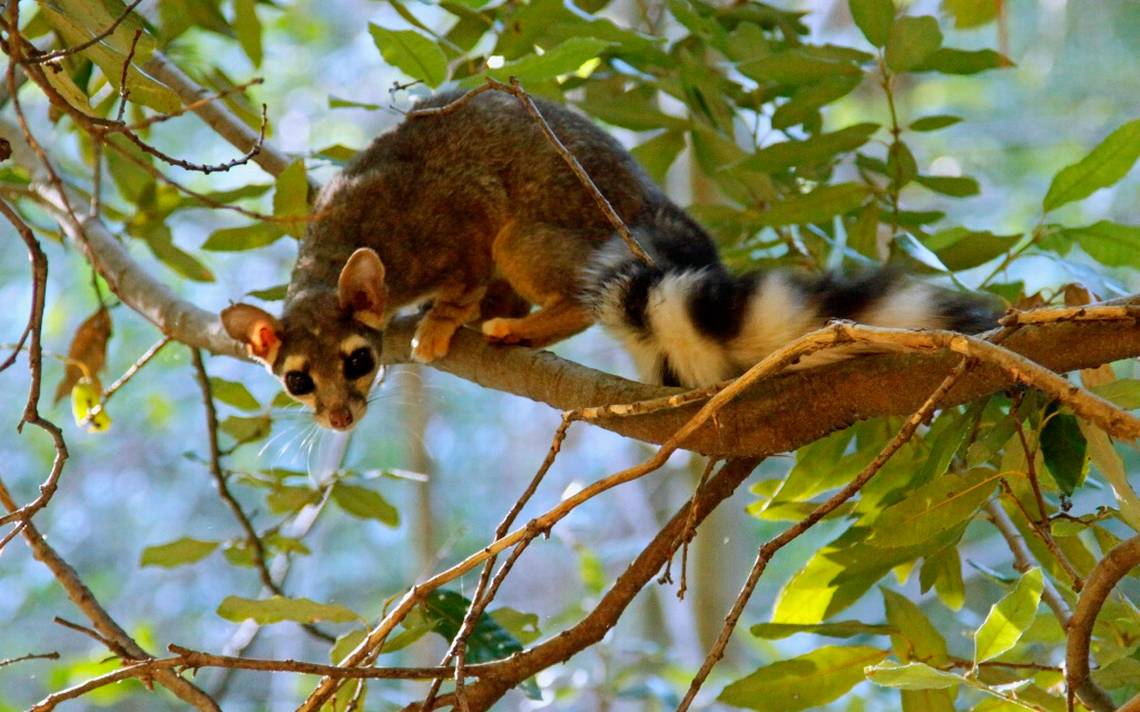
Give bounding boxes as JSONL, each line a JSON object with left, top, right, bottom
{"left": 221, "top": 92, "right": 988, "bottom": 429}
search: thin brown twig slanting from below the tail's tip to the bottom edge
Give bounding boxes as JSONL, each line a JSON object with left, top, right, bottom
{"left": 677, "top": 358, "right": 972, "bottom": 712}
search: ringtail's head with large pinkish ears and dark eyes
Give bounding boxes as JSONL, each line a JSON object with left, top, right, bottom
{"left": 221, "top": 248, "right": 386, "bottom": 431}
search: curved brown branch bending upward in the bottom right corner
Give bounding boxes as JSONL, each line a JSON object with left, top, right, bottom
{"left": 1065, "top": 535, "right": 1140, "bottom": 712}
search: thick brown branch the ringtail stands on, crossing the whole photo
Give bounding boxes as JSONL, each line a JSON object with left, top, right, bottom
{"left": 24, "top": 185, "right": 1140, "bottom": 457}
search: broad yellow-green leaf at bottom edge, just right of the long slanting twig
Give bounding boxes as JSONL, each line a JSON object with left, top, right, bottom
{"left": 717, "top": 645, "right": 887, "bottom": 712}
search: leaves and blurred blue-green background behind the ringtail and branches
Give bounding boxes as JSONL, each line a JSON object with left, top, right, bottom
{"left": 0, "top": 0, "right": 1140, "bottom": 710}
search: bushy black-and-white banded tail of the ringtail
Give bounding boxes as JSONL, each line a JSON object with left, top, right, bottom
{"left": 584, "top": 207, "right": 998, "bottom": 387}
